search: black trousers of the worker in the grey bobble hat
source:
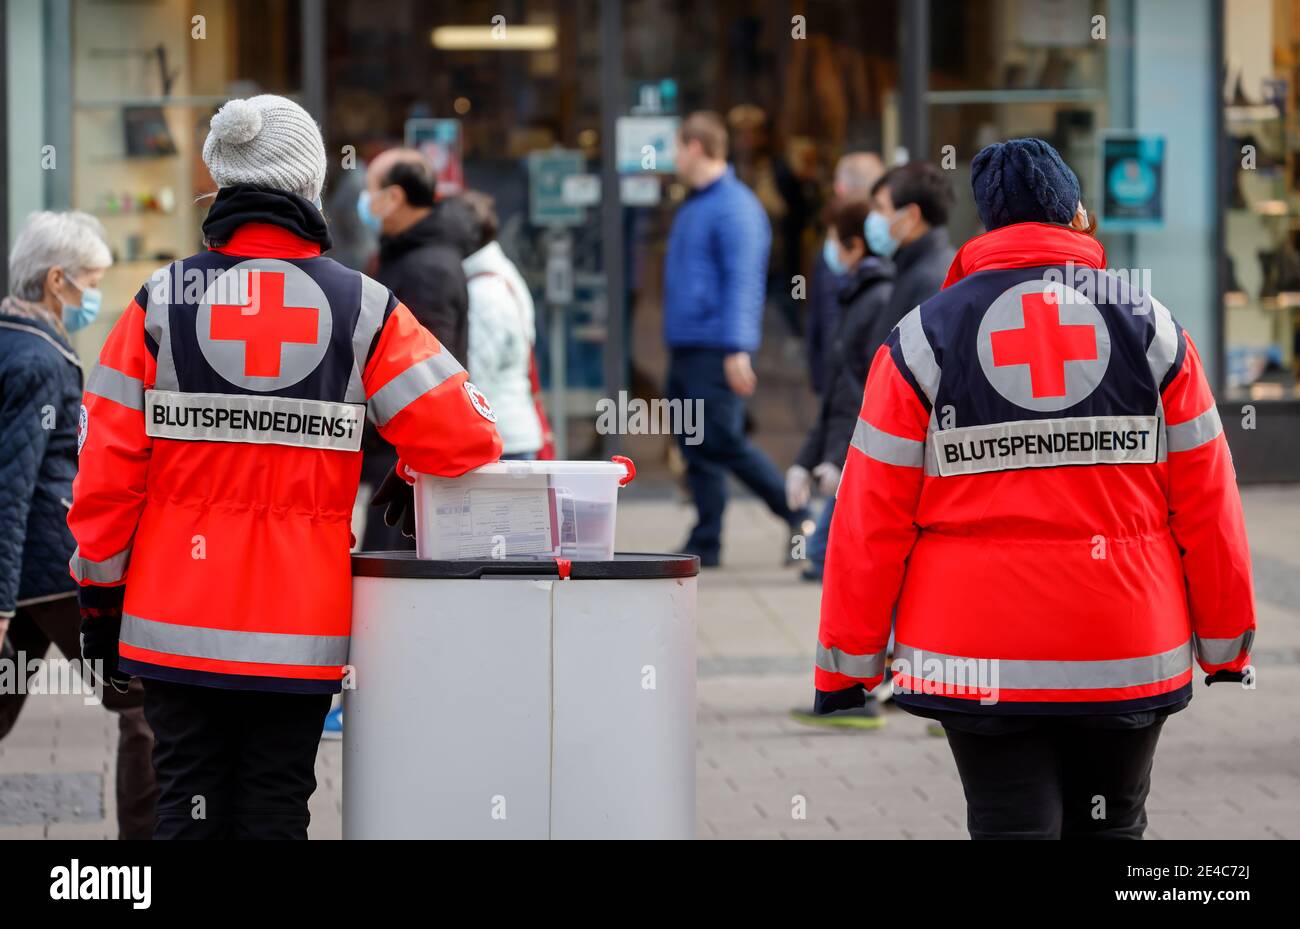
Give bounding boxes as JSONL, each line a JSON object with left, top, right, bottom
{"left": 144, "top": 680, "right": 330, "bottom": 839}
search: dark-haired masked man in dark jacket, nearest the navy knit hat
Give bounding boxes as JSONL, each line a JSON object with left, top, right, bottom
{"left": 865, "top": 161, "right": 953, "bottom": 356}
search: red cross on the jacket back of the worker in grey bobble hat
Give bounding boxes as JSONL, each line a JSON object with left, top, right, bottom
{"left": 211, "top": 270, "right": 320, "bottom": 377}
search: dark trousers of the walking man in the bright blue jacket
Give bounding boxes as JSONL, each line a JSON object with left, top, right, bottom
{"left": 666, "top": 348, "right": 802, "bottom": 556}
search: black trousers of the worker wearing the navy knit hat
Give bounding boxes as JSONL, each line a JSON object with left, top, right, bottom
{"left": 944, "top": 720, "right": 1165, "bottom": 839}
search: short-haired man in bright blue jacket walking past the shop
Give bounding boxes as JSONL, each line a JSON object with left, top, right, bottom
{"left": 663, "top": 112, "right": 807, "bottom": 568}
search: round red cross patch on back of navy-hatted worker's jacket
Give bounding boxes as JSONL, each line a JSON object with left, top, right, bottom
{"left": 976, "top": 279, "right": 1110, "bottom": 412}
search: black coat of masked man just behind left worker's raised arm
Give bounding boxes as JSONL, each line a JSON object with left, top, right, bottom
{"left": 374, "top": 197, "right": 477, "bottom": 364}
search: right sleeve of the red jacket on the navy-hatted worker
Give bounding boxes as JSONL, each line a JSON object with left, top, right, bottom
{"left": 1161, "top": 333, "right": 1255, "bottom": 673}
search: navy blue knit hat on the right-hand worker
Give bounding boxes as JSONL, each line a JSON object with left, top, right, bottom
{"left": 971, "top": 139, "right": 1079, "bottom": 229}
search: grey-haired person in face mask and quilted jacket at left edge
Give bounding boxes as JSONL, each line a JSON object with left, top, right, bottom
{"left": 0, "top": 212, "right": 156, "bottom": 838}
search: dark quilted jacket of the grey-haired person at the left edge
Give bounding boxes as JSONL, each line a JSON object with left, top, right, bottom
{"left": 0, "top": 314, "right": 82, "bottom": 616}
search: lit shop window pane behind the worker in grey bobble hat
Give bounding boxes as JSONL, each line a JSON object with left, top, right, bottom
{"left": 69, "top": 0, "right": 300, "bottom": 359}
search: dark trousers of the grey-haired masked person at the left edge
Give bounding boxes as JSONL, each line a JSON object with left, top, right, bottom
{"left": 0, "top": 594, "right": 157, "bottom": 839}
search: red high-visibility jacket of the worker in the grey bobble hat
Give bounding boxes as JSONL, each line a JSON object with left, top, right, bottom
{"left": 68, "top": 222, "right": 501, "bottom": 691}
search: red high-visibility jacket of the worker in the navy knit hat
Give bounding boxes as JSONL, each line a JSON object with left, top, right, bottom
{"left": 816, "top": 223, "right": 1255, "bottom": 715}
